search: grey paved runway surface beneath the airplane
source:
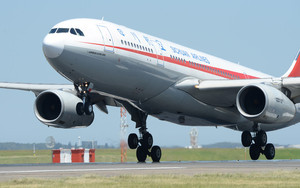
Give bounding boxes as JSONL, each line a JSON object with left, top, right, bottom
{"left": 0, "top": 160, "right": 300, "bottom": 181}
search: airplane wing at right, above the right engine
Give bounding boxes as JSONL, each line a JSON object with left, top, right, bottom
{"left": 175, "top": 77, "right": 300, "bottom": 107}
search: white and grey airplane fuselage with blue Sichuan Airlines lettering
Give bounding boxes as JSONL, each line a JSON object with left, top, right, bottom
{"left": 44, "top": 19, "right": 296, "bottom": 131}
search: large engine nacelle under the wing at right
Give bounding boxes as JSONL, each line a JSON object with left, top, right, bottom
{"left": 236, "top": 84, "right": 296, "bottom": 123}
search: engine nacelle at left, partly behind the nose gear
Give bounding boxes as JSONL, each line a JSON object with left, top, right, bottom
{"left": 34, "top": 90, "right": 94, "bottom": 128}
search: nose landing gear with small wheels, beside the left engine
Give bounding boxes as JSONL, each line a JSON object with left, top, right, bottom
{"left": 74, "top": 82, "right": 93, "bottom": 116}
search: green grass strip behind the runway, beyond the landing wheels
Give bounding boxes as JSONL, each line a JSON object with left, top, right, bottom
{"left": 0, "top": 148, "right": 300, "bottom": 164}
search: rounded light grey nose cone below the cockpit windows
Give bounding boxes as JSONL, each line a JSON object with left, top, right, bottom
{"left": 43, "top": 35, "right": 64, "bottom": 58}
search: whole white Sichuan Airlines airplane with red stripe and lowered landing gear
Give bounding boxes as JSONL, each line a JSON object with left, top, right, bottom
{"left": 0, "top": 18, "right": 300, "bottom": 162}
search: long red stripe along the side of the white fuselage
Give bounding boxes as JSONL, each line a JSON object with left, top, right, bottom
{"left": 82, "top": 42, "right": 258, "bottom": 79}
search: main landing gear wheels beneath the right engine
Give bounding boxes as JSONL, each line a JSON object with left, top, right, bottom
{"left": 242, "top": 130, "right": 275, "bottom": 160}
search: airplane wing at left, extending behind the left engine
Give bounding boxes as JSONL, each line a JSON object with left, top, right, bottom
{"left": 0, "top": 82, "right": 120, "bottom": 113}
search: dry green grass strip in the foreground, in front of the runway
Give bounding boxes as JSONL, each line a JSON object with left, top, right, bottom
{"left": 0, "top": 171, "right": 300, "bottom": 188}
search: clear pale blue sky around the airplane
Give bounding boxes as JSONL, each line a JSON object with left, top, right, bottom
{"left": 0, "top": 0, "right": 300, "bottom": 146}
